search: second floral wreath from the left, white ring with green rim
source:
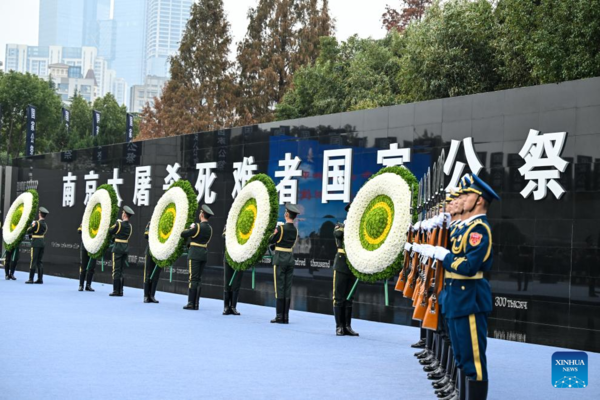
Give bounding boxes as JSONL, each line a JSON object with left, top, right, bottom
{"left": 81, "top": 185, "right": 119, "bottom": 259}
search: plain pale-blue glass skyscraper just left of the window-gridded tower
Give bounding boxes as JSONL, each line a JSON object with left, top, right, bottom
{"left": 111, "top": 0, "right": 146, "bottom": 85}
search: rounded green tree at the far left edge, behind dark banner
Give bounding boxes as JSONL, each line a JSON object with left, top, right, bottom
{"left": 0, "top": 71, "right": 61, "bottom": 162}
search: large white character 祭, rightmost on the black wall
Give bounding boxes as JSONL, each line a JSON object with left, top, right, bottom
{"left": 519, "top": 129, "right": 569, "bottom": 200}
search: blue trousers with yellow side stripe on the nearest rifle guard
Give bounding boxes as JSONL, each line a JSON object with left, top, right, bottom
{"left": 447, "top": 313, "right": 488, "bottom": 381}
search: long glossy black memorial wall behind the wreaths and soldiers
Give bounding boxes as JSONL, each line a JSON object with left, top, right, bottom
{"left": 11, "top": 78, "right": 600, "bottom": 351}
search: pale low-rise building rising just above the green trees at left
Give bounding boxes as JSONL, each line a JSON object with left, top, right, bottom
{"left": 48, "top": 64, "right": 99, "bottom": 105}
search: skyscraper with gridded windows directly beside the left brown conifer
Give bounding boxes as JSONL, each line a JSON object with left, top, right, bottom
{"left": 144, "top": 0, "right": 194, "bottom": 77}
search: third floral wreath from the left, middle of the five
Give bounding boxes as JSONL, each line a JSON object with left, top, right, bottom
{"left": 148, "top": 180, "right": 198, "bottom": 268}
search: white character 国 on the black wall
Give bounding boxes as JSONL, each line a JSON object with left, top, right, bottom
{"left": 321, "top": 149, "right": 352, "bottom": 203}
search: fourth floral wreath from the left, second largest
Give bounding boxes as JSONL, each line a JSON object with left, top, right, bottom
{"left": 225, "top": 174, "right": 279, "bottom": 271}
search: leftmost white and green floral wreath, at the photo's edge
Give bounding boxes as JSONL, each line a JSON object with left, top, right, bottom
{"left": 2, "top": 189, "right": 39, "bottom": 251}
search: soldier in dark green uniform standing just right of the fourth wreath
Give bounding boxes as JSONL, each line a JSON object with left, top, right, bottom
{"left": 270, "top": 204, "right": 300, "bottom": 324}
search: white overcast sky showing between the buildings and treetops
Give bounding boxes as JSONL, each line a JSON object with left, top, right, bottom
{"left": 0, "top": 0, "right": 400, "bottom": 67}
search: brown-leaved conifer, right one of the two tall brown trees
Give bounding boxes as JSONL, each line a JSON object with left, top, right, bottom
{"left": 237, "top": 0, "right": 333, "bottom": 124}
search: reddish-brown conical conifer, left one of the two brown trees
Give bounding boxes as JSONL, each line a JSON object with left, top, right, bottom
{"left": 140, "top": 0, "right": 236, "bottom": 139}
